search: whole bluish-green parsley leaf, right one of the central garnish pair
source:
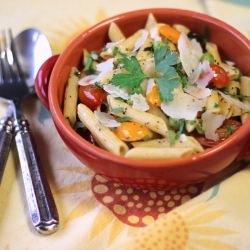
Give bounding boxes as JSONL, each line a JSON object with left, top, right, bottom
{"left": 154, "top": 42, "right": 182, "bottom": 101}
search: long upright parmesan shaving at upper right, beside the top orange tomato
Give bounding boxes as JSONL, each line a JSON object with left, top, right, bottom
{"left": 178, "top": 32, "right": 203, "bottom": 76}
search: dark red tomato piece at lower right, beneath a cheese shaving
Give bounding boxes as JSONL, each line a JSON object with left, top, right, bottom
{"left": 196, "top": 119, "right": 241, "bottom": 148}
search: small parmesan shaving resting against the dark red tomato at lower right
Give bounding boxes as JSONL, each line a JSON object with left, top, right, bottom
{"left": 201, "top": 111, "right": 225, "bottom": 141}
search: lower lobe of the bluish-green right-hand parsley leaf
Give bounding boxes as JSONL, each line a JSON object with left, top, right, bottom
{"left": 155, "top": 66, "right": 181, "bottom": 101}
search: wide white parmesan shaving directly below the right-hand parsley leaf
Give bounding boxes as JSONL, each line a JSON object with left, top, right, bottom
{"left": 161, "top": 92, "right": 205, "bottom": 120}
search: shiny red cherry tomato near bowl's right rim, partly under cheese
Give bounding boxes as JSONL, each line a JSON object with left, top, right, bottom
{"left": 210, "top": 64, "right": 229, "bottom": 88}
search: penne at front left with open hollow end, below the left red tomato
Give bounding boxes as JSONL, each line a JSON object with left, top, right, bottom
{"left": 77, "top": 104, "right": 128, "bottom": 155}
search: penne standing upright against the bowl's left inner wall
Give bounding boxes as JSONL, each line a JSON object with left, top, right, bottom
{"left": 63, "top": 67, "right": 79, "bottom": 126}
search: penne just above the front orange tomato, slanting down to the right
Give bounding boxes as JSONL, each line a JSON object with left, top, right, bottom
{"left": 107, "top": 95, "right": 168, "bottom": 137}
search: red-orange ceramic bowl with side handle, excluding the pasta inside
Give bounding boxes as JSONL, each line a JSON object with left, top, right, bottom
{"left": 36, "top": 9, "right": 250, "bottom": 189}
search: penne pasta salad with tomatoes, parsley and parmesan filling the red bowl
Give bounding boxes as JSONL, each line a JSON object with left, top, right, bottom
{"left": 63, "top": 14, "right": 250, "bottom": 159}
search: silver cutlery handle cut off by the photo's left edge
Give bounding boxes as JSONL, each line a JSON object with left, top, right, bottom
{"left": 0, "top": 117, "right": 13, "bottom": 184}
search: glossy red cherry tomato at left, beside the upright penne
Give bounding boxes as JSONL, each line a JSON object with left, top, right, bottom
{"left": 78, "top": 85, "right": 106, "bottom": 110}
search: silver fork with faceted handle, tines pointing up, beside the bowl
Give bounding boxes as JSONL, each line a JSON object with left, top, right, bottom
{"left": 0, "top": 30, "right": 59, "bottom": 234}
